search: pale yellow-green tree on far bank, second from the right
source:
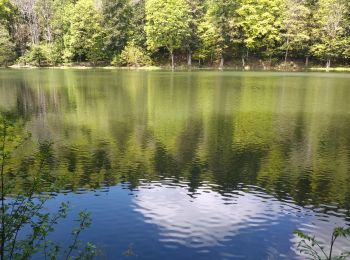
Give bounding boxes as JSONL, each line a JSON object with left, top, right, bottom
{"left": 281, "top": 0, "right": 310, "bottom": 63}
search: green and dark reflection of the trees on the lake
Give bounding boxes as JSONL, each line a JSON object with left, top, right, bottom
{"left": 0, "top": 70, "right": 350, "bottom": 258}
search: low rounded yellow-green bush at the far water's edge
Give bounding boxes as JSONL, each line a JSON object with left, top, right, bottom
{"left": 111, "top": 42, "right": 152, "bottom": 67}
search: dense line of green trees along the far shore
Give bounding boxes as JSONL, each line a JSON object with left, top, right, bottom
{"left": 0, "top": 0, "right": 350, "bottom": 67}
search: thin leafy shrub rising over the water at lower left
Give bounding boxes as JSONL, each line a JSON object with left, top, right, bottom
{"left": 0, "top": 114, "right": 96, "bottom": 260}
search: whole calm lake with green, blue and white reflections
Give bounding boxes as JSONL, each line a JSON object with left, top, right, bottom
{"left": 0, "top": 69, "right": 350, "bottom": 259}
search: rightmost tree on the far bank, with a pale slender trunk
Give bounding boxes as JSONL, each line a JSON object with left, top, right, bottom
{"left": 311, "top": 0, "right": 346, "bottom": 69}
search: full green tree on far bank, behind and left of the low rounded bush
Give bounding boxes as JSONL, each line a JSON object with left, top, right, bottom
{"left": 65, "top": 0, "right": 105, "bottom": 64}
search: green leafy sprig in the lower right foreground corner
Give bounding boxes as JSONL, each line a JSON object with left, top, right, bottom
{"left": 294, "top": 227, "right": 350, "bottom": 260}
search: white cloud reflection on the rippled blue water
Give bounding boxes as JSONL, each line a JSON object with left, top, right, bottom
{"left": 134, "top": 184, "right": 284, "bottom": 248}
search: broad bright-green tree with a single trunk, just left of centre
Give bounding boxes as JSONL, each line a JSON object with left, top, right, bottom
{"left": 146, "top": 0, "right": 191, "bottom": 69}
